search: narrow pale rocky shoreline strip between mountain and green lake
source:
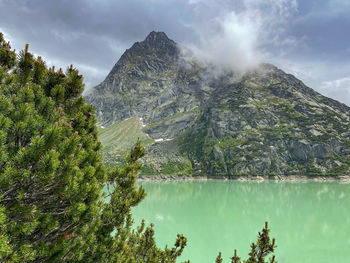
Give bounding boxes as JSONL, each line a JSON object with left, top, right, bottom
{"left": 137, "top": 175, "right": 350, "bottom": 182}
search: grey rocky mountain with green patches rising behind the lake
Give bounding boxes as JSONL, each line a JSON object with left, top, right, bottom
{"left": 86, "top": 32, "right": 350, "bottom": 176}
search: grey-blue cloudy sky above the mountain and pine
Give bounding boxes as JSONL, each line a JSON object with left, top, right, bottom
{"left": 0, "top": 0, "right": 350, "bottom": 105}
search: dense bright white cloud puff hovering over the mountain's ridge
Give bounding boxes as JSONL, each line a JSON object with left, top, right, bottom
{"left": 185, "top": 9, "right": 261, "bottom": 71}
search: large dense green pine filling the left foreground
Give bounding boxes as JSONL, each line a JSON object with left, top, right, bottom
{"left": 0, "top": 34, "right": 186, "bottom": 263}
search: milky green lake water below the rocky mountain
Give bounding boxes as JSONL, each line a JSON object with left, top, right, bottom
{"left": 133, "top": 180, "right": 350, "bottom": 263}
